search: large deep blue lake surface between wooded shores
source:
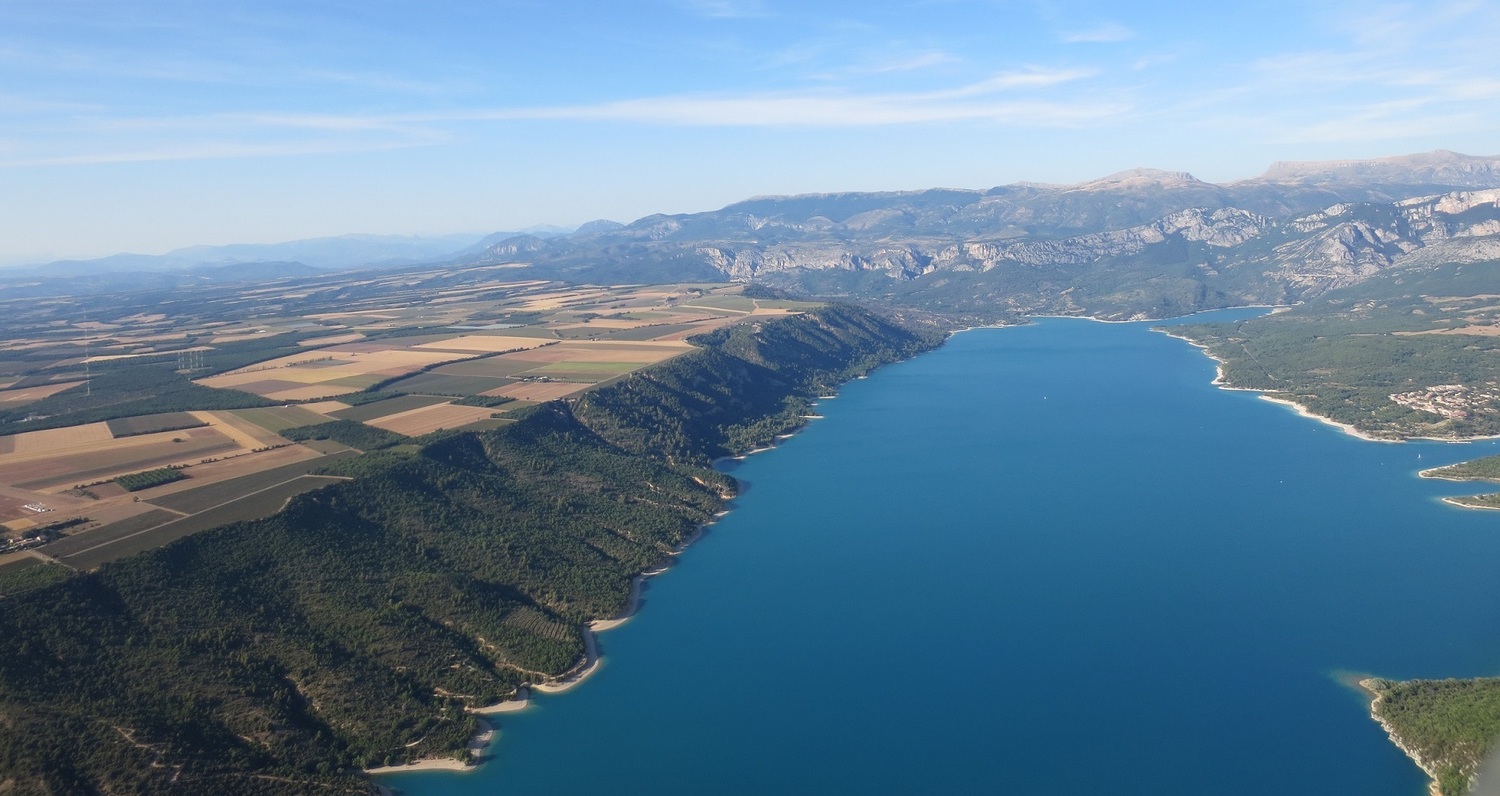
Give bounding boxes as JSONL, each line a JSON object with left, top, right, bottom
{"left": 381, "top": 310, "right": 1500, "bottom": 796}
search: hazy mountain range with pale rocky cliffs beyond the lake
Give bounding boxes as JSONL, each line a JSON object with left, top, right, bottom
{"left": 464, "top": 151, "right": 1500, "bottom": 318}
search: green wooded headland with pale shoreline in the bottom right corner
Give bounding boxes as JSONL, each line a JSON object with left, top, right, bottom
{"left": 1362, "top": 678, "right": 1500, "bottom": 796}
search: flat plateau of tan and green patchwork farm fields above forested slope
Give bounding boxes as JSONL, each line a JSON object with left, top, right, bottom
{"left": 0, "top": 271, "right": 812, "bottom": 568}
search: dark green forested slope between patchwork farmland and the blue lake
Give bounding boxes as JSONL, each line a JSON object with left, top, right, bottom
{"left": 0, "top": 304, "right": 942, "bottom": 795}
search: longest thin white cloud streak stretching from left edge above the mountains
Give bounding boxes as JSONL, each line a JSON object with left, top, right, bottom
{"left": 0, "top": 69, "right": 1131, "bottom": 166}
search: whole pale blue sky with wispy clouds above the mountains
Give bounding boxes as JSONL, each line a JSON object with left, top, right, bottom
{"left": 0, "top": 0, "right": 1500, "bottom": 262}
